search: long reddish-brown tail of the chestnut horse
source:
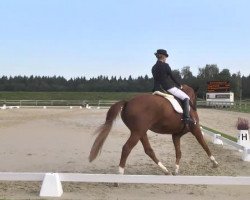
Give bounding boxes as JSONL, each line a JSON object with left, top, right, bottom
{"left": 89, "top": 101, "right": 126, "bottom": 162}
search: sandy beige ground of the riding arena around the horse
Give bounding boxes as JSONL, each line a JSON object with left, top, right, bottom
{"left": 0, "top": 108, "right": 250, "bottom": 200}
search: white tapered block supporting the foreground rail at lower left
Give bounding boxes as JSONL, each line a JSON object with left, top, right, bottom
{"left": 40, "top": 173, "right": 63, "bottom": 197}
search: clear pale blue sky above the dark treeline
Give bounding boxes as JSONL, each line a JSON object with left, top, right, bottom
{"left": 0, "top": 0, "right": 250, "bottom": 79}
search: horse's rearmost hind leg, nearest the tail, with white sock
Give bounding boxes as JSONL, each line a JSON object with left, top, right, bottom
{"left": 119, "top": 132, "right": 143, "bottom": 174}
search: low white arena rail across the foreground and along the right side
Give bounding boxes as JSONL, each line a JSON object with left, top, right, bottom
{"left": 0, "top": 129, "right": 250, "bottom": 197}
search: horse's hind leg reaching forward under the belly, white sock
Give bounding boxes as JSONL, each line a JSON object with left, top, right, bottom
{"left": 141, "top": 134, "right": 170, "bottom": 175}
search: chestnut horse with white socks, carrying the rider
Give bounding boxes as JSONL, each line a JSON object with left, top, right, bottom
{"left": 89, "top": 85, "right": 218, "bottom": 174}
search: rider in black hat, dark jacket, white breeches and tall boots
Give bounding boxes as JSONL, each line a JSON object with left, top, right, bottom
{"left": 152, "top": 49, "right": 193, "bottom": 124}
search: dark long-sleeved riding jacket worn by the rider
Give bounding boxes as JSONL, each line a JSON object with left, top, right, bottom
{"left": 152, "top": 61, "right": 181, "bottom": 92}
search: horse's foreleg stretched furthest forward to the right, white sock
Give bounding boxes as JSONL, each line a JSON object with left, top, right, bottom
{"left": 191, "top": 125, "right": 218, "bottom": 167}
